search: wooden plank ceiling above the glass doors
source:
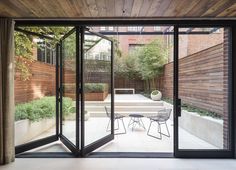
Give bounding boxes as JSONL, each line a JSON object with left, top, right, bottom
{"left": 0, "top": 0, "right": 236, "bottom": 18}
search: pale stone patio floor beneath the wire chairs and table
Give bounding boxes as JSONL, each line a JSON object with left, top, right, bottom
{"left": 28, "top": 94, "right": 217, "bottom": 152}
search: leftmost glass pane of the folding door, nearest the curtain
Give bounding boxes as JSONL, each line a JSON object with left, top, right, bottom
{"left": 14, "top": 35, "right": 56, "bottom": 146}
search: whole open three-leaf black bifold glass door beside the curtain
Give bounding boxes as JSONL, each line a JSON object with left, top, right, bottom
{"left": 16, "top": 27, "right": 114, "bottom": 156}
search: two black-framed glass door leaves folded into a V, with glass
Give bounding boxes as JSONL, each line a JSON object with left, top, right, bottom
{"left": 59, "top": 27, "right": 114, "bottom": 156}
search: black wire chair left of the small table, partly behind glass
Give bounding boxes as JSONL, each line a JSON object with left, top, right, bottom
{"left": 105, "top": 106, "right": 126, "bottom": 135}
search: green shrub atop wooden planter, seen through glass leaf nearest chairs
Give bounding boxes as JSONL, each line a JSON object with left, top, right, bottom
{"left": 84, "top": 83, "right": 108, "bottom": 93}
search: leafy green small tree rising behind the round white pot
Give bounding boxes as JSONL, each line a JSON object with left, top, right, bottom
{"left": 136, "top": 39, "right": 168, "bottom": 92}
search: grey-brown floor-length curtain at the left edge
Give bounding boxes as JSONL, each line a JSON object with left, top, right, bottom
{"left": 0, "top": 18, "right": 15, "bottom": 164}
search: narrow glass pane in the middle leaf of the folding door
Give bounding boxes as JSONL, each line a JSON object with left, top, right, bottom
{"left": 61, "top": 32, "right": 76, "bottom": 145}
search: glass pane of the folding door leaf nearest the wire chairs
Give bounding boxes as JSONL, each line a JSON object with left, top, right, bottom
{"left": 84, "top": 32, "right": 111, "bottom": 145}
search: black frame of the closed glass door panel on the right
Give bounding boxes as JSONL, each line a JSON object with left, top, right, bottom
{"left": 173, "top": 25, "right": 234, "bottom": 158}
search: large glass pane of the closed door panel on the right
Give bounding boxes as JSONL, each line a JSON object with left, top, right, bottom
{"left": 178, "top": 27, "right": 229, "bottom": 149}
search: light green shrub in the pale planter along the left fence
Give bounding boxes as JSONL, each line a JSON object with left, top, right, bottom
{"left": 15, "top": 96, "right": 73, "bottom": 121}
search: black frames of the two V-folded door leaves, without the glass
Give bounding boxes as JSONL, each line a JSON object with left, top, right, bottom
{"left": 59, "top": 26, "right": 114, "bottom": 157}
